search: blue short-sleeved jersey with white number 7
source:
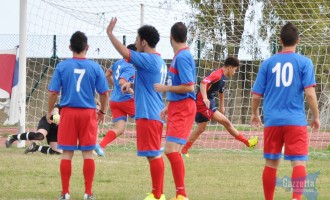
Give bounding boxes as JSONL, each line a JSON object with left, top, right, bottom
{"left": 48, "top": 58, "right": 109, "bottom": 108}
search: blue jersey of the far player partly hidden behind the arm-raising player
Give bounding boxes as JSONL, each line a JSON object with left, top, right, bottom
{"left": 109, "top": 59, "right": 135, "bottom": 102}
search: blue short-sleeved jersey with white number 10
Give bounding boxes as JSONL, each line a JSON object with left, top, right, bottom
{"left": 252, "top": 52, "right": 316, "bottom": 127}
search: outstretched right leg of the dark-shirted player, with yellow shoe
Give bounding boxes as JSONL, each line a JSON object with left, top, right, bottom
{"left": 212, "top": 111, "right": 258, "bottom": 148}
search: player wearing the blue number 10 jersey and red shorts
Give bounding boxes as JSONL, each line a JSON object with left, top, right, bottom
{"left": 251, "top": 22, "right": 320, "bottom": 200}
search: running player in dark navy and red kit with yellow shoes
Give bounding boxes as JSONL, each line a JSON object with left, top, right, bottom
{"left": 181, "top": 57, "right": 258, "bottom": 157}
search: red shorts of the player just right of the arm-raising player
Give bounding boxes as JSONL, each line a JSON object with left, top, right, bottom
{"left": 166, "top": 98, "right": 196, "bottom": 144}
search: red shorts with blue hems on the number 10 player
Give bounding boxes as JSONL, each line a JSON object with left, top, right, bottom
{"left": 264, "top": 126, "right": 308, "bottom": 160}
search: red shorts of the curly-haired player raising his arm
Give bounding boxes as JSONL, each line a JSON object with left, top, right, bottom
{"left": 135, "top": 119, "right": 163, "bottom": 157}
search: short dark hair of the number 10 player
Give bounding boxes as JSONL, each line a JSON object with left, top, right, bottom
{"left": 280, "top": 22, "right": 299, "bottom": 46}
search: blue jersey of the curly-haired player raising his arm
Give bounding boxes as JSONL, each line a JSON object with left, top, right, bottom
{"left": 129, "top": 50, "right": 167, "bottom": 122}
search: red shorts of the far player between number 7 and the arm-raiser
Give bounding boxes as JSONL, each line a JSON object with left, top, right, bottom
{"left": 109, "top": 99, "right": 135, "bottom": 122}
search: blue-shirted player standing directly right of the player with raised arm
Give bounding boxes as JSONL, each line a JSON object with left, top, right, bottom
{"left": 154, "top": 22, "right": 196, "bottom": 200}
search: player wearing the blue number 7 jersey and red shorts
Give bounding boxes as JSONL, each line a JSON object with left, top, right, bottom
{"left": 46, "top": 31, "right": 109, "bottom": 199}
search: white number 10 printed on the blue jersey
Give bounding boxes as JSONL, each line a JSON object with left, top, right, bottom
{"left": 272, "top": 62, "right": 293, "bottom": 87}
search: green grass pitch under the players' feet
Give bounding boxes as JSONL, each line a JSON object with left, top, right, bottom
{"left": 0, "top": 146, "right": 330, "bottom": 200}
